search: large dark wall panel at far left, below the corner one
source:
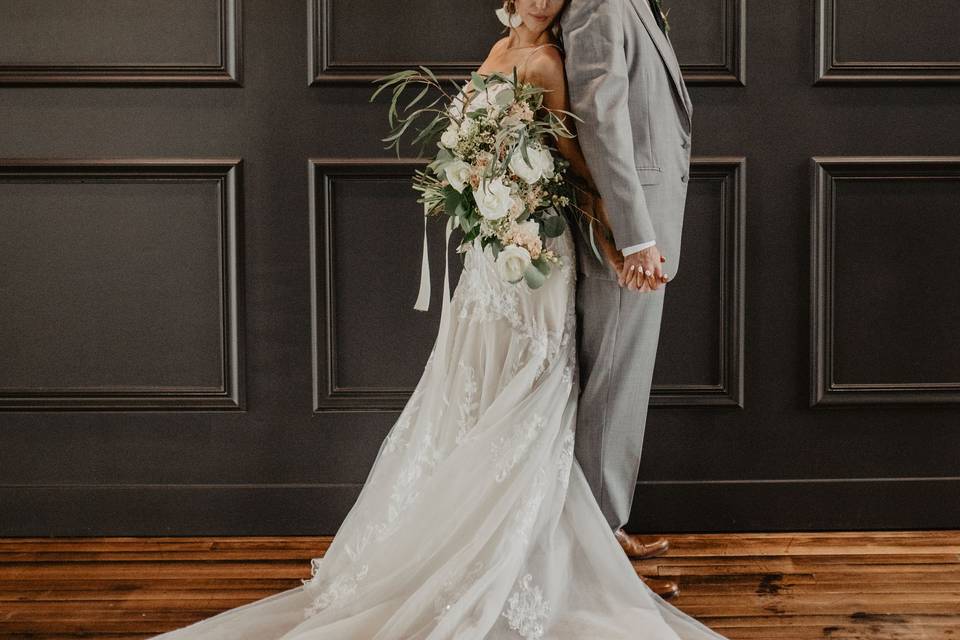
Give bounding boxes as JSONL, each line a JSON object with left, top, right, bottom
{"left": 0, "top": 158, "right": 245, "bottom": 411}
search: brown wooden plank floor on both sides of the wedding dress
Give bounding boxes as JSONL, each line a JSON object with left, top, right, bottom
{"left": 0, "top": 531, "right": 960, "bottom": 640}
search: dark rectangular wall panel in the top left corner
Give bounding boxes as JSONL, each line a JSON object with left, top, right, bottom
{"left": 0, "top": 0, "right": 241, "bottom": 84}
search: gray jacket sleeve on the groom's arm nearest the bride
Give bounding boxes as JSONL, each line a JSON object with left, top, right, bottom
{"left": 563, "top": 0, "right": 655, "bottom": 249}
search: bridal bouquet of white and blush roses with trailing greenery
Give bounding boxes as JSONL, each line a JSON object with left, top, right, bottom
{"left": 370, "top": 66, "right": 599, "bottom": 298}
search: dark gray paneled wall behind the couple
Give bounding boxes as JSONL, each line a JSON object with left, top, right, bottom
{"left": 0, "top": 0, "right": 960, "bottom": 536}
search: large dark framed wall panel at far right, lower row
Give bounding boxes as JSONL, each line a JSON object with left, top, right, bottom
{"left": 811, "top": 157, "right": 960, "bottom": 405}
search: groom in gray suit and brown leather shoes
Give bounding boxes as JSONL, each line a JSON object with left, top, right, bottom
{"left": 560, "top": 0, "right": 693, "bottom": 597}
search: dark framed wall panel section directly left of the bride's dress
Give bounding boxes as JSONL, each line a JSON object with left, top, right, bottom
{"left": 309, "top": 158, "right": 460, "bottom": 411}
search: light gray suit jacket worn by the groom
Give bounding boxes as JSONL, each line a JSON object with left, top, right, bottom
{"left": 560, "top": 0, "right": 693, "bottom": 279}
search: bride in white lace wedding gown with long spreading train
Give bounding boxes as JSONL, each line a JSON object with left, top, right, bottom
{"left": 155, "top": 0, "right": 723, "bottom": 640}
